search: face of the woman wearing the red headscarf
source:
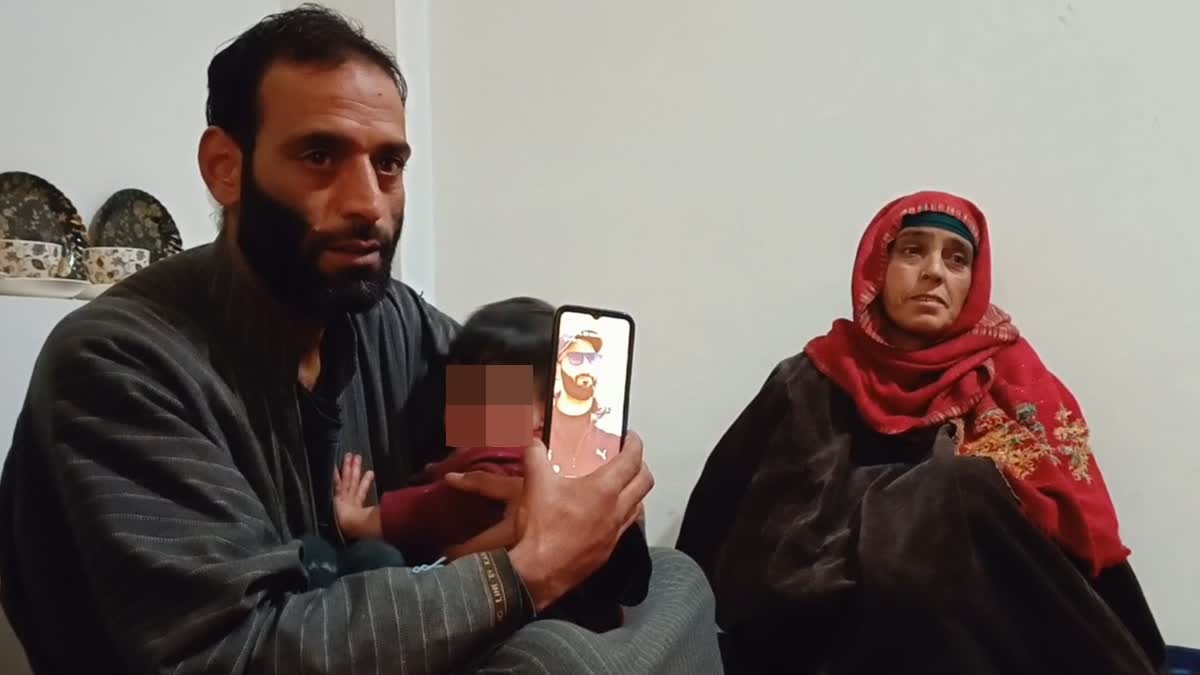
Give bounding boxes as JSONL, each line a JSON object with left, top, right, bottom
{"left": 882, "top": 227, "right": 974, "bottom": 350}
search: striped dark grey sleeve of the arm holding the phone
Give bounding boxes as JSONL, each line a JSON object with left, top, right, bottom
{"left": 39, "top": 317, "right": 533, "bottom": 675}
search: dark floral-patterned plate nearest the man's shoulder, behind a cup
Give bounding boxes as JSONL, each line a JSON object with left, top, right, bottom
{"left": 88, "top": 187, "right": 184, "bottom": 263}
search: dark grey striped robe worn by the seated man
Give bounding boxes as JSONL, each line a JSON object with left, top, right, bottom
{"left": 0, "top": 234, "right": 719, "bottom": 675}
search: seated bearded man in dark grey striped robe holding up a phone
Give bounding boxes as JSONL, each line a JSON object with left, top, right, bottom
{"left": 0, "top": 6, "right": 720, "bottom": 674}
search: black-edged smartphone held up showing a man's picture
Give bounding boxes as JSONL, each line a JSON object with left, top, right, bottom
{"left": 542, "top": 305, "right": 634, "bottom": 477}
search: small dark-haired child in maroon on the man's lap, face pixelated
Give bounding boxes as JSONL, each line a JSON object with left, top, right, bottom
{"left": 334, "top": 298, "right": 649, "bottom": 629}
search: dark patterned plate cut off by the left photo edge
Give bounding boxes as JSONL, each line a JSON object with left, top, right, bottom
{"left": 0, "top": 171, "right": 88, "bottom": 281}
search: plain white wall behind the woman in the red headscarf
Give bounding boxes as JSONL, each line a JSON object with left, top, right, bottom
{"left": 431, "top": 0, "right": 1200, "bottom": 645}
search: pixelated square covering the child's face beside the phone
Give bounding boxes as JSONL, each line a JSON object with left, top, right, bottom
{"left": 445, "top": 365, "right": 546, "bottom": 448}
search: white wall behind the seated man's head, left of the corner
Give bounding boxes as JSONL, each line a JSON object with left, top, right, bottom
{"left": 0, "top": 0, "right": 433, "bottom": 298}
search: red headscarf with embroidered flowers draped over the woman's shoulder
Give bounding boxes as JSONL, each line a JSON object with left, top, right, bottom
{"left": 805, "top": 192, "right": 1129, "bottom": 573}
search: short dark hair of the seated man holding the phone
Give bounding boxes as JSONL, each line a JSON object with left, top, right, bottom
{"left": 205, "top": 4, "right": 408, "bottom": 154}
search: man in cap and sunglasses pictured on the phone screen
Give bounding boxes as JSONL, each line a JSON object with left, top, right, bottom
{"left": 550, "top": 330, "right": 620, "bottom": 477}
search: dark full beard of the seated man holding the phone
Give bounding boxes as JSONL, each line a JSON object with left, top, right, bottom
{"left": 238, "top": 167, "right": 403, "bottom": 319}
